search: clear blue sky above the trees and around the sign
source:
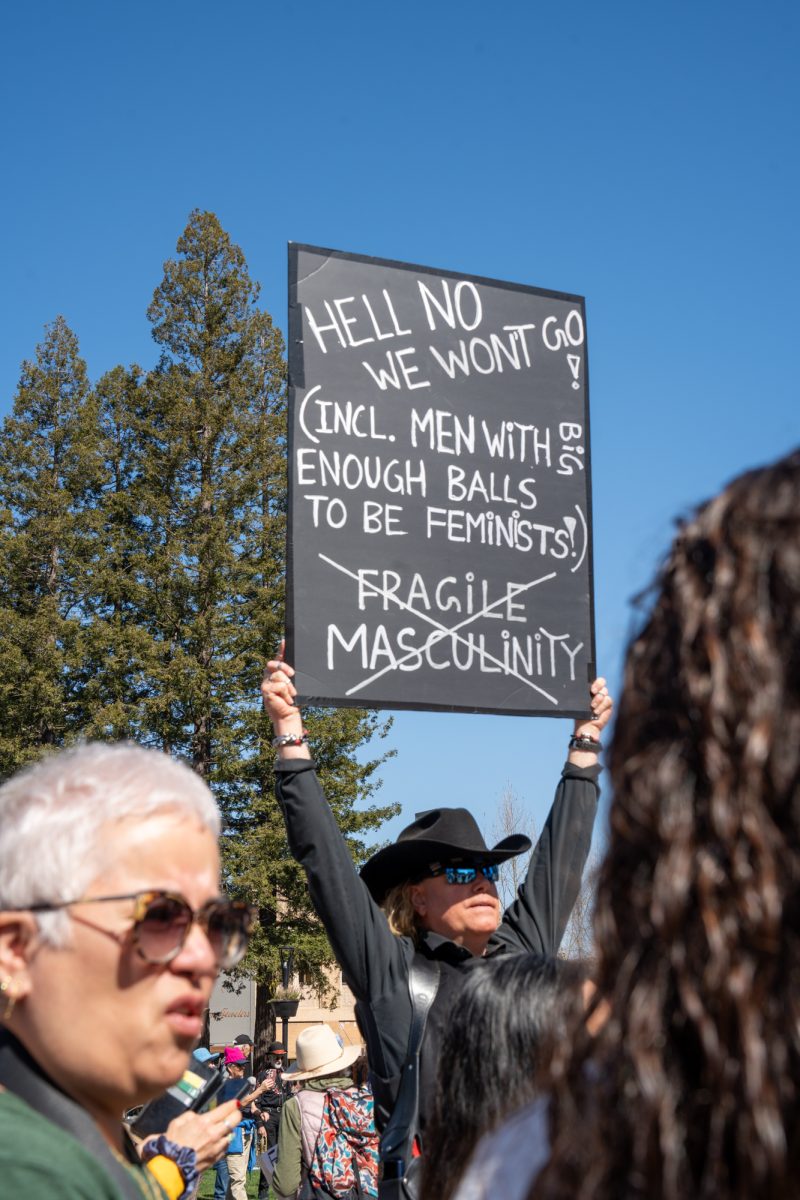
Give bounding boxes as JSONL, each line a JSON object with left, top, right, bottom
{"left": 0, "top": 0, "right": 800, "bottom": 833}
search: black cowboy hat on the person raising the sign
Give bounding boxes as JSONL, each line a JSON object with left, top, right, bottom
{"left": 361, "top": 809, "right": 530, "bottom": 904}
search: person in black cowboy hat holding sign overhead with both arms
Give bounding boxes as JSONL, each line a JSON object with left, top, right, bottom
{"left": 261, "top": 659, "right": 612, "bottom": 1156}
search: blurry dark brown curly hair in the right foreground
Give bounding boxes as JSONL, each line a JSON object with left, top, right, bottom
{"left": 530, "top": 451, "right": 800, "bottom": 1200}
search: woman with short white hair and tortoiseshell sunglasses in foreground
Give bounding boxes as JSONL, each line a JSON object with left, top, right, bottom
{"left": 0, "top": 745, "right": 252, "bottom": 1200}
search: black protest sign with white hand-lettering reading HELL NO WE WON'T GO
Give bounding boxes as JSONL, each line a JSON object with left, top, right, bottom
{"left": 287, "top": 245, "right": 594, "bottom": 716}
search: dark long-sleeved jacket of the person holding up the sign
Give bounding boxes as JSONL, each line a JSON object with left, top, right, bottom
{"left": 276, "top": 758, "right": 600, "bottom": 1132}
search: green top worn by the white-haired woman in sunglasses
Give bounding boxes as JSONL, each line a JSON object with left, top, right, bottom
{"left": 0, "top": 1090, "right": 164, "bottom": 1200}
